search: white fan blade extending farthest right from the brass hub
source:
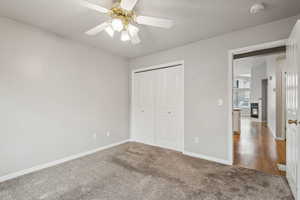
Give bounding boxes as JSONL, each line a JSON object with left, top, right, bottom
{"left": 136, "top": 16, "right": 174, "bottom": 28}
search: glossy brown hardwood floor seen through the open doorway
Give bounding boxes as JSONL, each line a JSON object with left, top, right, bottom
{"left": 233, "top": 118, "right": 286, "bottom": 175}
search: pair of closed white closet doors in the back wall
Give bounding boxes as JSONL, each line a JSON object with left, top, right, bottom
{"left": 132, "top": 64, "right": 184, "bottom": 151}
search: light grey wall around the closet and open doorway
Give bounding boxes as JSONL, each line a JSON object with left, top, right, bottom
{"left": 130, "top": 16, "right": 299, "bottom": 160}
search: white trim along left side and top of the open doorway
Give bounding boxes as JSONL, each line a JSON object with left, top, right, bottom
{"left": 227, "top": 39, "right": 287, "bottom": 165}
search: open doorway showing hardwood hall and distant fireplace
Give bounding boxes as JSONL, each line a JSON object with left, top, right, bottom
{"left": 231, "top": 43, "right": 286, "bottom": 175}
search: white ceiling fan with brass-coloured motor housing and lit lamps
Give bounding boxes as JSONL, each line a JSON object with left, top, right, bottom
{"left": 81, "top": 0, "right": 173, "bottom": 44}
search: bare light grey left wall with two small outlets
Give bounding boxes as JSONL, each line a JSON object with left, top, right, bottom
{"left": 0, "top": 18, "right": 129, "bottom": 176}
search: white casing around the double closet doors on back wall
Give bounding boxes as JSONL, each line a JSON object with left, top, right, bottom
{"left": 129, "top": 60, "right": 185, "bottom": 152}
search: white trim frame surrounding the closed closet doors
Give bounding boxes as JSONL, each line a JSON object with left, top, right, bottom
{"left": 130, "top": 60, "right": 185, "bottom": 152}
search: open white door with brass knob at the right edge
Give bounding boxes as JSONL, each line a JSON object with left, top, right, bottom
{"left": 286, "top": 20, "right": 300, "bottom": 199}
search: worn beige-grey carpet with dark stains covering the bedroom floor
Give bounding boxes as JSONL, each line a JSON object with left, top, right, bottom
{"left": 0, "top": 143, "right": 293, "bottom": 200}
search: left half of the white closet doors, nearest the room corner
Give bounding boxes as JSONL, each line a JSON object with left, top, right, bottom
{"left": 132, "top": 71, "right": 155, "bottom": 144}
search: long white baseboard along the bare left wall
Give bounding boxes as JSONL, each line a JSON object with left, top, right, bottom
{"left": 0, "top": 140, "right": 130, "bottom": 183}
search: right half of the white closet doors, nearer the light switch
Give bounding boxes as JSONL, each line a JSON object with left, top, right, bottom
{"left": 155, "top": 66, "right": 184, "bottom": 151}
